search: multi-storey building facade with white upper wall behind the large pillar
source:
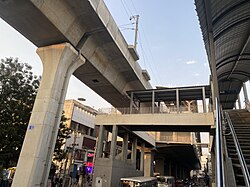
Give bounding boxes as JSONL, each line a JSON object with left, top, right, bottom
{"left": 64, "top": 100, "right": 97, "bottom": 181}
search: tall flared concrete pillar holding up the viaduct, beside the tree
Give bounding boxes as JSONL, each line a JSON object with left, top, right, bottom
{"left": 12, "top": 43, "right": 85, "bottom": 187}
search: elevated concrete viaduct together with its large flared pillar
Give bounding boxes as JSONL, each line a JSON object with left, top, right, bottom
{"left": 0, "top": 0, "right": 152, "bottom": 187}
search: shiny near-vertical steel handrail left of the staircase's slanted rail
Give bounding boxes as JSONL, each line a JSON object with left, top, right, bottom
{"left": 215, "top": 98, "right": 225, "bottom": 187}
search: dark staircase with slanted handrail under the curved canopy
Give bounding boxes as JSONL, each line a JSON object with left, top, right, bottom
{"left": 225, "top": 110, "right": 250, "bottom": 187}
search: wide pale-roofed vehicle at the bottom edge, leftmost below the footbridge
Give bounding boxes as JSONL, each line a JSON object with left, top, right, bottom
{"left": 121, "top": 177, "right": 157, "bottom": 187}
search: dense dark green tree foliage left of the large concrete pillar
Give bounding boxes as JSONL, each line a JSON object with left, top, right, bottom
{"left": 0, "top": 58, "right": 40, "bottom": 167}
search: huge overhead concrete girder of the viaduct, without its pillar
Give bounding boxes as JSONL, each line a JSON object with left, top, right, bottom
{"left": 0, "top": 0, "right": 151, "bottom": 107}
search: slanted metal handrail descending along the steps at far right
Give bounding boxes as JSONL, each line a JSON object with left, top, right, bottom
{"left": 225, "top": 112, "right": 250, "bottom": 187}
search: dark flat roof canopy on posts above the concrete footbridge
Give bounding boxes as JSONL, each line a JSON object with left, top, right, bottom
{"left": 127, "top": 85, "right": 211, "bottom": 102}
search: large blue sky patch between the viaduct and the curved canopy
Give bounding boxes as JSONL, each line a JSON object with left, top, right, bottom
{"left": 105, "top": 0, "right": 210, "bottom": 86}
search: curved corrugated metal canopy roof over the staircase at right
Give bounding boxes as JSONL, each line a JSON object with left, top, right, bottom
{"left": 195, "top": 0, "right": 250, "bottom": 109}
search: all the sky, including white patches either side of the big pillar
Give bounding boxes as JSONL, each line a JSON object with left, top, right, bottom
{"left": 0, "top": 0, "right": 210, "bottom": 108}
